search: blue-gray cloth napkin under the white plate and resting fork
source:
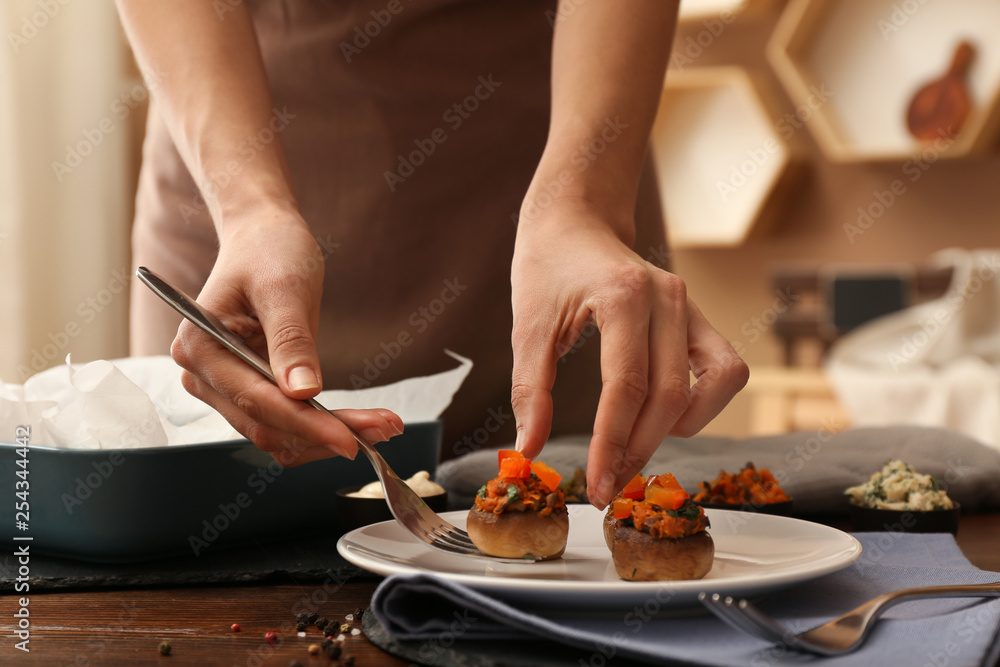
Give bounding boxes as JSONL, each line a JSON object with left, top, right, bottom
{"left": 371, "top": 533, "right": 1000, "bottom": 667}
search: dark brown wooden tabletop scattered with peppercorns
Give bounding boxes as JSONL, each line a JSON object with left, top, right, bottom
{"left": 0, "top": 513, "right": 1000, "bottom": 667}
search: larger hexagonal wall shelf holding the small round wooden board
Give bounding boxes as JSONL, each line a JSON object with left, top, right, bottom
{"left": 768, "top": 0, "right": 1000, "bottom": 162}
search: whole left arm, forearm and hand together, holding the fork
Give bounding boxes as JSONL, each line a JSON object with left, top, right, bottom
{"left": 117, "top": 0, "right": 403, "bottom": 466}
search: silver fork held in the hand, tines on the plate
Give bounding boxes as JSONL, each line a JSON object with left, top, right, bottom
{"left": 136, "top": 266, "right": 539, "bottom": 563}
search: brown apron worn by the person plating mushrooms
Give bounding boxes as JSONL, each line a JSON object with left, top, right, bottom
{"left": 131, "top": 0, "right": 666, "bottom": 459}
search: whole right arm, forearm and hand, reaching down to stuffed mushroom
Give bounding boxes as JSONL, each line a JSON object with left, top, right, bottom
{"left": 511, "top": 0, "right": 749, "bottom": 507}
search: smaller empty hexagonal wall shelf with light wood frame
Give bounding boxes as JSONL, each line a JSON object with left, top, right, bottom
{"left": 652, "top": 67, "right": 795, "bottom": 246}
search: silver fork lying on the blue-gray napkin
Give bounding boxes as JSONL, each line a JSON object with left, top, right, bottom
{"left": 698, "top": 582, "right": 1000, "bottom": 656}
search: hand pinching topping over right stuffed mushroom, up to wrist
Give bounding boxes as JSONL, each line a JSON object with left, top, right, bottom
{"left": 511, "top": 200, "right": 749, "bottom": 508}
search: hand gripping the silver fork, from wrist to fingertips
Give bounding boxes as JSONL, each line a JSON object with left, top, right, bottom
{"left": 170, "top": 211, "right": 403, "bottom": 466}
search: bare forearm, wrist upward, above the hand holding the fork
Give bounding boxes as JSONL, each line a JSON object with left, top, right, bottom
{"left": 117, "top": 0, "right": 295, "bottom": 236}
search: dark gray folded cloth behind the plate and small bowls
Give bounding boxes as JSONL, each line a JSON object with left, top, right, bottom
{"left": 436, "top": 426, "right": 1000, "bottom": 515}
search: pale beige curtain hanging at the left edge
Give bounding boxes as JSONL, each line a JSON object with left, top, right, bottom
{"left": 0, "top": 0, "right": 132, "bottom": 384}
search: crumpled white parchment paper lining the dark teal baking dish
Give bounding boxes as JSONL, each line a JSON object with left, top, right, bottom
{"left": 0, "top": 350, "right": 472, "bottom": 449}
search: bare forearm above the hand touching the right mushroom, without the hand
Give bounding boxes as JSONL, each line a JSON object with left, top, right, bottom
{"left": 522, "top": 0, "right": 678, "bottom": 239}
